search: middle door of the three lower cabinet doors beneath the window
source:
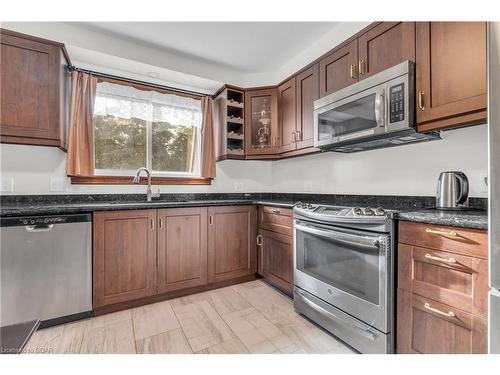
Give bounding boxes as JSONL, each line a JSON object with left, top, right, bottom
{"left": 157, "top": 207, "right": 207, "bottom": 293}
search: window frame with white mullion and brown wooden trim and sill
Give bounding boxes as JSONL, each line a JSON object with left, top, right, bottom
{"left": 71, "top": 77, "right": 212, "bottom": 185}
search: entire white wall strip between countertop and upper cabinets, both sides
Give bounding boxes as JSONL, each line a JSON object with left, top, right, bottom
{"left": 0, "top": 125, "right": 488, "bottom": 197}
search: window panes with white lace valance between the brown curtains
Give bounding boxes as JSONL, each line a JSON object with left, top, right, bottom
{"left": 94, "top": 82, "right": 202, "bottom": 178}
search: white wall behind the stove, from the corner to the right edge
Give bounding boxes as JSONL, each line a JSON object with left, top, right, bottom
{"left": 272, "top": 125, "right": 488, "bottom": 198}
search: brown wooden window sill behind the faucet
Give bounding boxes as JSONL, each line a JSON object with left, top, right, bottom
{"left": 71, "top": 176, "right": 212, "bottom": 185}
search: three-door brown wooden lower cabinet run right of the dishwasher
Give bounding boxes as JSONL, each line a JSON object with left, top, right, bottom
{"left": 93, "top": 206, "right": 257, "bottom": 315}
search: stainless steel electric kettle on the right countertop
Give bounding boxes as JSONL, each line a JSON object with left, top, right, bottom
{"left": 436, "top": 171, "right": 469, "bottom": 210}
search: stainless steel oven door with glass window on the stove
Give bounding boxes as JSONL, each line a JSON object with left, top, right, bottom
{"left": 294, "top": 220, "right": 390, "bottom": 332}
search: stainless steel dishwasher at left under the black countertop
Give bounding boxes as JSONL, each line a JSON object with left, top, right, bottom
{"left": 0, "top": 214, "right": 92, "bottom": 327}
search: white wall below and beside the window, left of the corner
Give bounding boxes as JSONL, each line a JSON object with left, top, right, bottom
{"left": 0, "top": 144, "right": 272, "bottom": 195}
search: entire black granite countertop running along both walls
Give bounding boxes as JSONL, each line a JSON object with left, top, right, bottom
{"left": 0, "top": 193, "right": 488, "bottom": 229}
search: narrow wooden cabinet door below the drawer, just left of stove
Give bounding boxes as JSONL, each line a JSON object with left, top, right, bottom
{"left": 258, "top": 229, "right": 293, "bottom": 295}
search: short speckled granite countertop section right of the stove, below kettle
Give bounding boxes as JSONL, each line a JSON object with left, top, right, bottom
{"left": 394, "top": 208, "right": 488, "bottom": 230}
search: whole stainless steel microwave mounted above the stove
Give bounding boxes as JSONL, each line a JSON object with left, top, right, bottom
{"left": 314, "top": 61, "right": 440, "bottom": 152}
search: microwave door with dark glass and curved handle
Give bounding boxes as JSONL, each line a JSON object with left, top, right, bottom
{"left": 314, "top": 84, "right": 386, "bottom": 148}
